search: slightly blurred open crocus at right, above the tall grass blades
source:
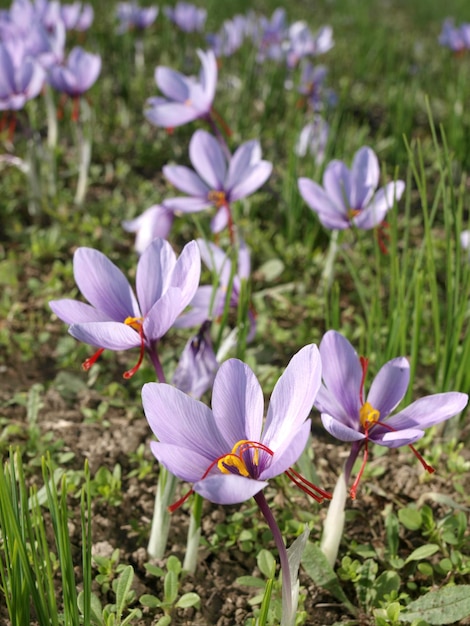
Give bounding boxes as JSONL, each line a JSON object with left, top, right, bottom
{"left": 298, "top": 146, "right": 405, "bottom": 230}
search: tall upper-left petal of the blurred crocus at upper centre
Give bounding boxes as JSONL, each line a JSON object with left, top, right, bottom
{"left": 189, "top": 130, "right": 226, "bottom": 190}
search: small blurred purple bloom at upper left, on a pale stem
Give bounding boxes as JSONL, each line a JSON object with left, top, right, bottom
{"left": 49, "top": 46, "right": 101, "bottom": 98}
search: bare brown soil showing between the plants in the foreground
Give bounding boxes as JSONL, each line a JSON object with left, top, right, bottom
{"left": 0, "top": 357, "right": 470, "bottom": 626}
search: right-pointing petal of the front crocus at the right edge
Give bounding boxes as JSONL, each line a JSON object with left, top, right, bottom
{"left": 385, "top": 391, "right": 468, "bottom": 430}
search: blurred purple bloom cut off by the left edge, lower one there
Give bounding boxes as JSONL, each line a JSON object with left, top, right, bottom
{"left": 0, "top": 39, "right": 46, "bottom": 111}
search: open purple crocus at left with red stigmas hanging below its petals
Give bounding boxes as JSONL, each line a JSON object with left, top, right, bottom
{"left": 49, "top": 239, "right": 201, "bottom": 379}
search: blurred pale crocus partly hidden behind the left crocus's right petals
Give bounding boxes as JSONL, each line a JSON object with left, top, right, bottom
{"left": 175, "top": 239, "right": 256, "bottom": 341}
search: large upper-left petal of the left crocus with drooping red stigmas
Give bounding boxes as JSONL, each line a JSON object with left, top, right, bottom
{"left": 73, "top": 248, "right": 140, "bottom": 322}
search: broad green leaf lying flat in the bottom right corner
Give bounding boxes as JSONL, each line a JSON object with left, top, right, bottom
{"left": 399, "top": 585, "right": 470, "bottom": 625}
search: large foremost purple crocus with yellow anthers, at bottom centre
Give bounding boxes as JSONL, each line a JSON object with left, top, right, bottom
{"left": 142, "top": 344, "right": 330, "bottom": 510}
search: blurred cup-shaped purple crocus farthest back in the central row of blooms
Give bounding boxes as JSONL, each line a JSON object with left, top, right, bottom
{"left": 145, "top": 50, "right": 217, "bottom": 128}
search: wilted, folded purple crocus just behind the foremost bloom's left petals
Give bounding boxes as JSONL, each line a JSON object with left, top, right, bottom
{"left": 173, "top": 320, "right": 219, "bottom": 398}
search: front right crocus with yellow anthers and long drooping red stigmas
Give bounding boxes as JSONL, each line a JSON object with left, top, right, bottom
{"left": 315, "top": 330, "right": 468, "bottom": 498}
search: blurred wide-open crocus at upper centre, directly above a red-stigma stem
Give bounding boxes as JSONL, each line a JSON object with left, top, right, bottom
{"left": 163, "top": 130, "right": 272, "bottom": 233}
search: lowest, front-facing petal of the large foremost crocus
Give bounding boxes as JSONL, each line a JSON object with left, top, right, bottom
{"left": 193, "top": 474, "right": 268, "bottom": 504}
